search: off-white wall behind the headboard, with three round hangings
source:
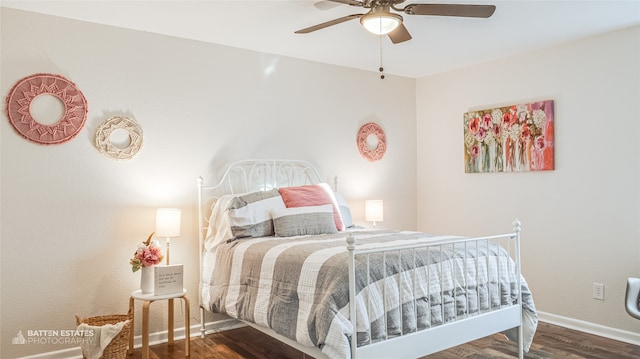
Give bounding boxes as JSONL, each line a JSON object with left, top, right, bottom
{"left": 0, "top": 8, "right": 416, "bottom": 358}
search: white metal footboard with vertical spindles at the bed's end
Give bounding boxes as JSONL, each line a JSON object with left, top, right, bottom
{"left": 347, "top": 220, "right": 524, "bottom": 358}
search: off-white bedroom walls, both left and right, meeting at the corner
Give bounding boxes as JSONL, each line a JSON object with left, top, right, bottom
{"left": 5, "top": 8, "right": 640, "bottom": 358}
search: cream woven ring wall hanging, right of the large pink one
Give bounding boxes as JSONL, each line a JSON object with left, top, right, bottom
{"left": 96, "top": 116, "right": 142, "bottom": 160}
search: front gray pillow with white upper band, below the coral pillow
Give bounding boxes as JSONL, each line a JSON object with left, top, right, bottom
{"left": 271, "top": 204, "right": 338, "bottom": 237}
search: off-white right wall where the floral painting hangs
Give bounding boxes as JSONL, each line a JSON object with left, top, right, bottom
{"left": 416, "top": 27, "right": 640, "bottom": 335}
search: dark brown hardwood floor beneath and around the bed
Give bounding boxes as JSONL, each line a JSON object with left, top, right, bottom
{"left": 128, "top": 323, "right": 640, "bottom": 359}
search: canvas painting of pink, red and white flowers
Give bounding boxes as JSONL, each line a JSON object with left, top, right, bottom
{"left": 464, "top": 100, "right": 554, "bottom": 173}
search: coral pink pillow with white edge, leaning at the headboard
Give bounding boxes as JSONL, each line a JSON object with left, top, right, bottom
{"left": 279, "top": 183, "right": 344, "bottom": 231}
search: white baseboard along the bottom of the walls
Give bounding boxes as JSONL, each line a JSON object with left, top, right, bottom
{"left": 18, "top": 312, "right": 640, "bottom": 359}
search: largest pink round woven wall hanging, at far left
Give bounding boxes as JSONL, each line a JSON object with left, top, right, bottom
{"left": 6, "top": 74, "right": 88, "bottom": 145}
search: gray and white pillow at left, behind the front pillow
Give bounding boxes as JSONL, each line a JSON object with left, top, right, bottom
{"left": 227, "top": 189, "right": 285, "bottom": 238}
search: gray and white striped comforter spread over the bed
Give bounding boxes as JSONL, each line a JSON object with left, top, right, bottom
{"left": 201, "top": 231, "right": 537, "bottom": 358}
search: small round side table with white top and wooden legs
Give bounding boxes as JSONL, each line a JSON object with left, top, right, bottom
{"left": 127, "top": 289, "right": 191, "bottom": 359}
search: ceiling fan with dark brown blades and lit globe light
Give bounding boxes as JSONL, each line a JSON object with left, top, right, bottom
{"left": 295, "top": 0, "right": 496, "bottom": 44}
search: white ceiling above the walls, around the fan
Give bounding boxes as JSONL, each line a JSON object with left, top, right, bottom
{"left": 1, "top": 0, "right": 640, "bottom": 78}
